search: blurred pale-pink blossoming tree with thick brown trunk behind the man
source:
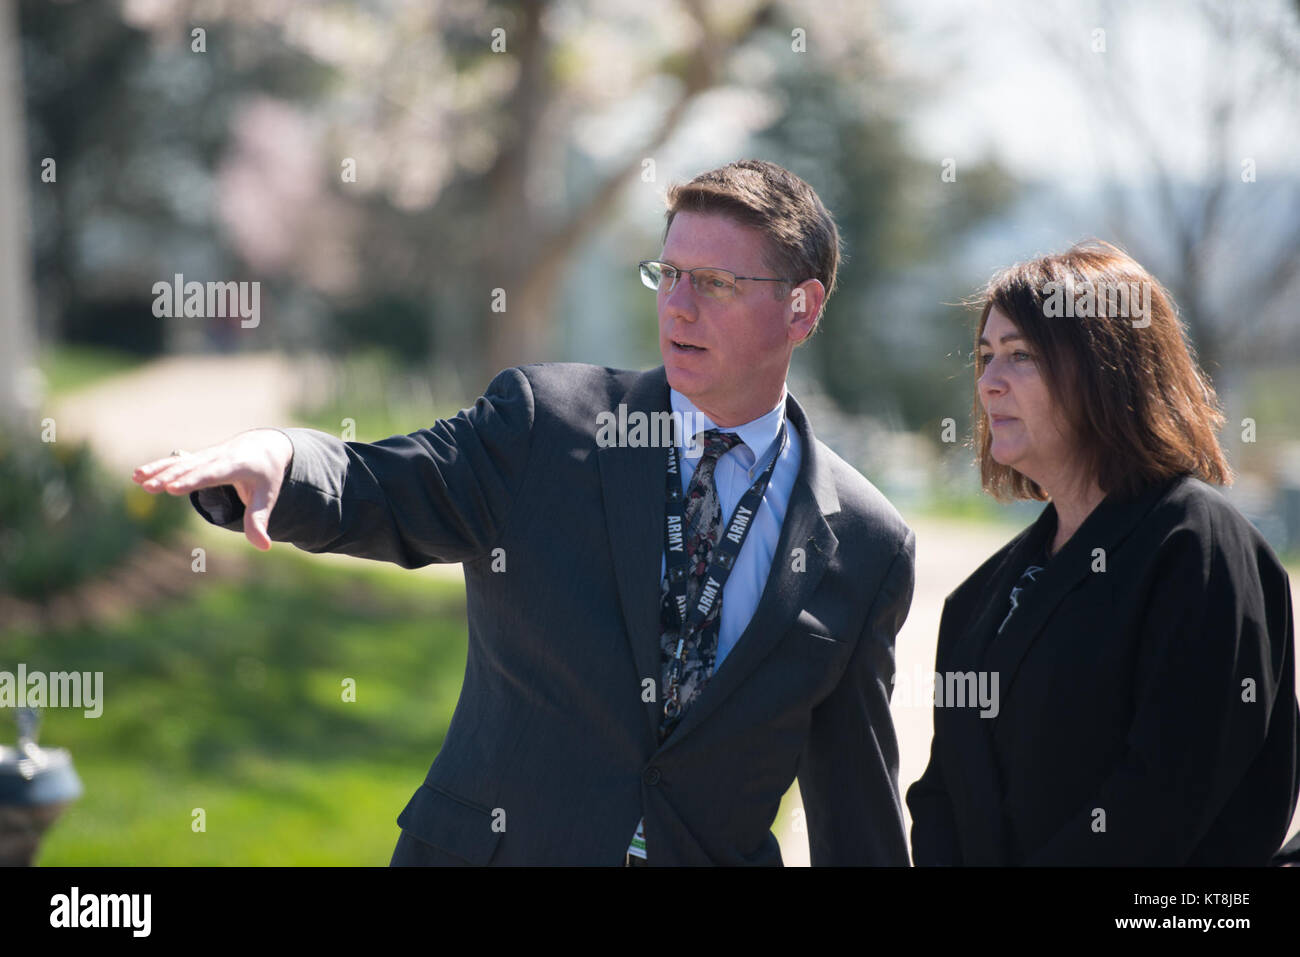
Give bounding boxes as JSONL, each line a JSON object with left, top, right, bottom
{"left": 122, "top": 0, "right": 909, "bottom": 385}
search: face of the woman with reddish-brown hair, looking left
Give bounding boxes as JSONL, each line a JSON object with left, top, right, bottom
{"left": 976, "top": 306, "right": 1074, "bottom": 489}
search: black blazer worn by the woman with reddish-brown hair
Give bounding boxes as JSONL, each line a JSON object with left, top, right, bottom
{"left": 907, "top": 476, "right": 1300, "bottom": 866}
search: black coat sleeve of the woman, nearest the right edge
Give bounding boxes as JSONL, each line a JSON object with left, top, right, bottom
{"left": 1024, "top": 515, "right": 1292, "bottom": 866}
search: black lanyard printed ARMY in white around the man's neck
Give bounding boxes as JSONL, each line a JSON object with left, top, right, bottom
{"left": 663, "top": 417, "right": 787, "bottom": 720}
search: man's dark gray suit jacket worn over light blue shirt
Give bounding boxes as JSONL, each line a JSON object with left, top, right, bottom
{"left": 192, "top": 363, "right": 915, "bottom": 866}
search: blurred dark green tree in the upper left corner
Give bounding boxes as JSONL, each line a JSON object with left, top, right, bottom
{"left": 21, "top": 0, "right": 335, "bottom": 354}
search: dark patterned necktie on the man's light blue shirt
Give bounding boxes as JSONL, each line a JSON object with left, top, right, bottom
{"left": 659, "top": 429, "right": 740, "bottom": 739}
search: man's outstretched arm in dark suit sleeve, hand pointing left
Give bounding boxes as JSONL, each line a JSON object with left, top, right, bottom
{"left": 133, "top": 368, "right": 534, "bottom": 568}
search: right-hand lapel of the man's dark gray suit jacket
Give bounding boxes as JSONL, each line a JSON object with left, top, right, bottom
{"left": 654, "top": 393, "right": 840, "bottom": 749}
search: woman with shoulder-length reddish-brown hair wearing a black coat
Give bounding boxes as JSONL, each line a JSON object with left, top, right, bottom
{"left": 907, "top": 243, "right": 1300, "bottom": 866}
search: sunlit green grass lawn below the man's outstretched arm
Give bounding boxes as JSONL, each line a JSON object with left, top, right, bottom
{"left": 0, "top": 546, "right": 465, "bottom": 865}
